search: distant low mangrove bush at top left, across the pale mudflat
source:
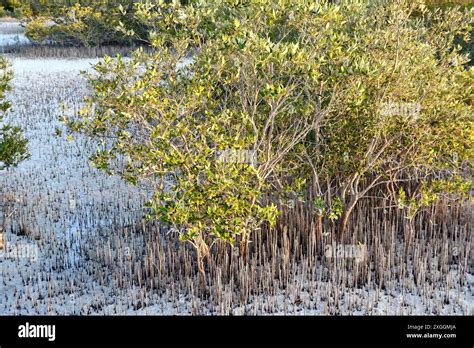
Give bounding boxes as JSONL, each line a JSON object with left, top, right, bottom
{"left": 21, "top": 0, "right": 186, "bottom": 46}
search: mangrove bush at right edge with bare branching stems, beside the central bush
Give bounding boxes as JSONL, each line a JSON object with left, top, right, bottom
{"left": 303, "top": 1, "right": 473, "bottom": 226}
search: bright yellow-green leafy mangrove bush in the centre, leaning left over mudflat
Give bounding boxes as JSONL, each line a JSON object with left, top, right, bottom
{"left": 64, "top": 1, "right": 352, "bottom": 253}
